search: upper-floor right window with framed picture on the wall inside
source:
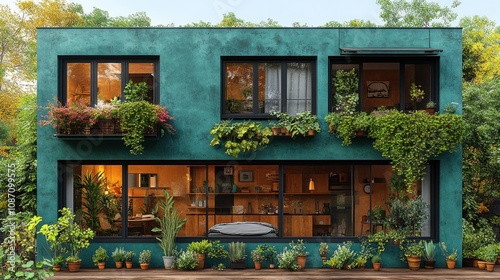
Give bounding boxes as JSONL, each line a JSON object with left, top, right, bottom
{"left": 330, "top": 57, "right": 439, "bottom": 113}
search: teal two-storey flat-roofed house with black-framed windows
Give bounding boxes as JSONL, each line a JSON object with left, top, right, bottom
{"left": 37, "top": 28, "right": 462, "bottom": 267}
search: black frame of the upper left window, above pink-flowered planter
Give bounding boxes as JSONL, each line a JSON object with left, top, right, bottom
{"left": 58, "top": 56, "right": 160, "bottom": 107}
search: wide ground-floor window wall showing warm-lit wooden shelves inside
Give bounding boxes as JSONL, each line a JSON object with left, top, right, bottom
{"left": 62, "top": 162, "right": 437, "bottom": 238}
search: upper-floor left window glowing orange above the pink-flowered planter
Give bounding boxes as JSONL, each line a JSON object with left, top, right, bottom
{"left": 61, "top": 57, "right": 158, "bottom": 106}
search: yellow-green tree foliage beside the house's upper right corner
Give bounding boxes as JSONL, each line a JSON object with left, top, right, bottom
{"left": 460, "top": 16, "right": 500, "bottom": 83}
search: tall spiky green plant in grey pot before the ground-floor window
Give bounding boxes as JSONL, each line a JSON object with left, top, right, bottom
{"left": 152, "top": 190, "right": 186, "bottom": 269}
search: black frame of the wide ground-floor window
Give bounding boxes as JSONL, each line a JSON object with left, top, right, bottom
{"left": 58, "top": 160, "right": 440, "bottom": 243}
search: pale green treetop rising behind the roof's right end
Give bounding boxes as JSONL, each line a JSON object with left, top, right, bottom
{"left": 377, "top": 0, "right": 460, "bottom": 27}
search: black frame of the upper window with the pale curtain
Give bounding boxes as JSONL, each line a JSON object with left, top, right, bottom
{"left": 220, "top": 56, "right": 317, "bottom": 119}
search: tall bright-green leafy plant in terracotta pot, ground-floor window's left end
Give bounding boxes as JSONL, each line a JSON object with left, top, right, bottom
{"left": 57, "top": 207, "right": 95, "bottom": 272}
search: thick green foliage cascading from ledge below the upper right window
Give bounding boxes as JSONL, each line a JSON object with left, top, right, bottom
{"left": 369, "top": 110, "right": 465, "bottom": 190}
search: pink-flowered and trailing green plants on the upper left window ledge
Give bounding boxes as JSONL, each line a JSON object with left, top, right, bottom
{"left": 40, "top": 80, "right": 175, "bottom": 155}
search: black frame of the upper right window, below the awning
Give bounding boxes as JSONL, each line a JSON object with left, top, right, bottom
{"left": 328, "top": 55, "right": 440, "bottom": 112}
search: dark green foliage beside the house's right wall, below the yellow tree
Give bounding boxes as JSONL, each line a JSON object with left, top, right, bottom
{"left": 463, "top": 78, "right": 500, "bottom": 221}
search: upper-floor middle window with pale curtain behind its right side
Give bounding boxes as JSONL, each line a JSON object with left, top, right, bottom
{"left": 222, "top": 58, "right": 316, "bottom": 118}
